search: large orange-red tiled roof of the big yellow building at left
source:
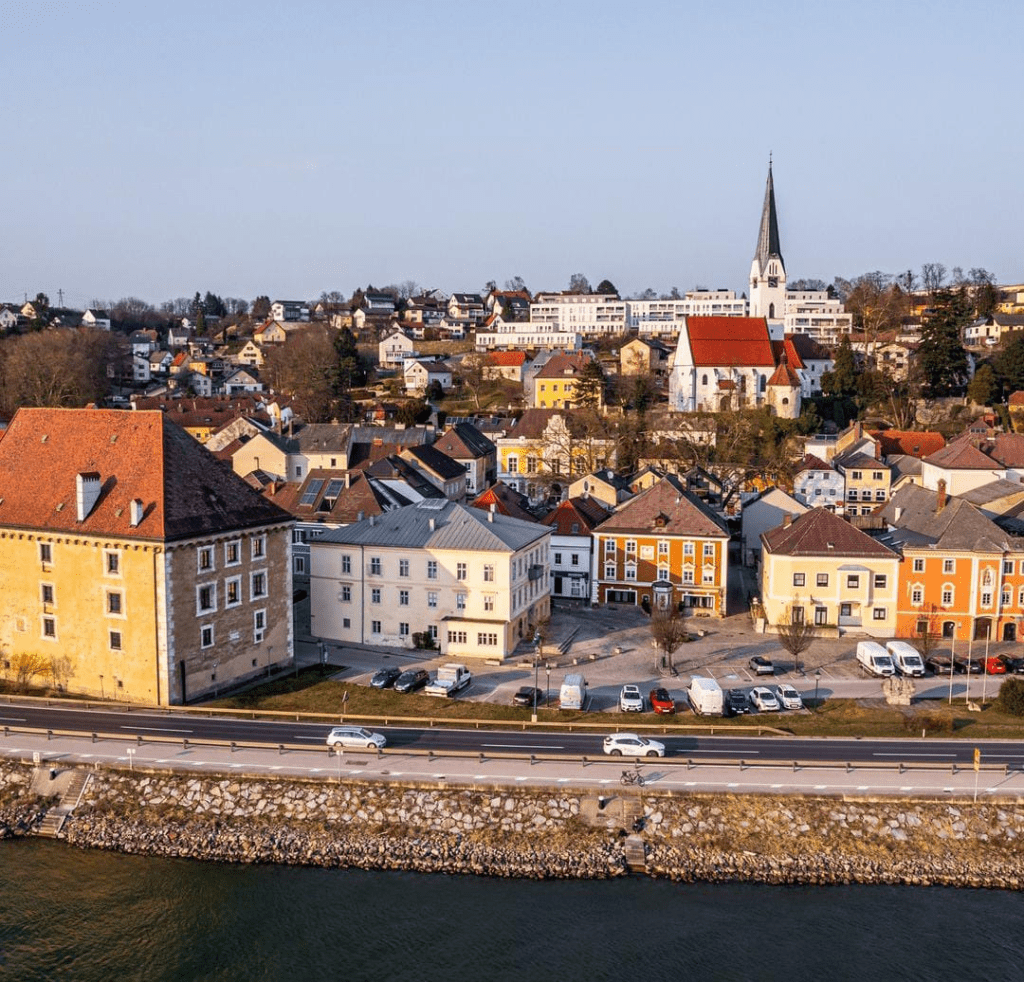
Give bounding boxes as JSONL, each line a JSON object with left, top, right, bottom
{"left": 0, "top": 409, "right": 289, "bottom": 541}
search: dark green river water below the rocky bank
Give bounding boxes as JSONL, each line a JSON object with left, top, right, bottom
{"left": 0, "top": 840, "right": 1024, "bottom": 982}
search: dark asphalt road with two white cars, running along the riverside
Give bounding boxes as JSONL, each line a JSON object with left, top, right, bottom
{"left": 0, "top": 703, "right": 1024, "bottom": 770}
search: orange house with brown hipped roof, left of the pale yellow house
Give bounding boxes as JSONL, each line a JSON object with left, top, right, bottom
{"left": 591, "top": 475, "right": 729, "bottom": 617}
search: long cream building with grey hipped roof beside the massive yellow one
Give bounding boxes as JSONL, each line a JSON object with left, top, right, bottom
{"left": 309, "top": 501, "right": 551, "bottom": 660}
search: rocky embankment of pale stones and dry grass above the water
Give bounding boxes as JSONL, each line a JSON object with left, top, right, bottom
{"left": 0, "top": 767, "right": 1024, "bottom": 890}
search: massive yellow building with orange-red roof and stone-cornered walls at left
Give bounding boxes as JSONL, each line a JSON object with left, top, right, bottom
{"left": 0, "top": 409, "right": 293, "bottom": 706}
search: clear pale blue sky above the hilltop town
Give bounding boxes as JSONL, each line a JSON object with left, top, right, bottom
{"left": 0, "top": 0, "right": 1024, "bottom": 307}
